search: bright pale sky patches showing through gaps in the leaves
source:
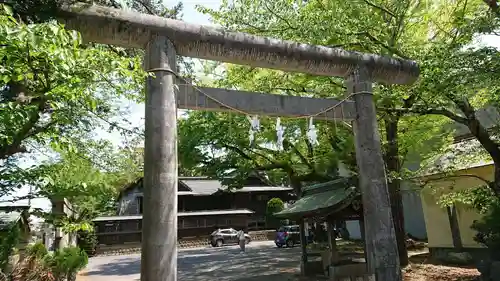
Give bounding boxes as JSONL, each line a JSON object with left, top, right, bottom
{"left": 2, "top": 0, "right": 500, "bottom": 210}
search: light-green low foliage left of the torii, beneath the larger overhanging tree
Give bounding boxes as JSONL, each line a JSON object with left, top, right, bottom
{"left": 27, "top": 144, "right": 129, "bottom": 233}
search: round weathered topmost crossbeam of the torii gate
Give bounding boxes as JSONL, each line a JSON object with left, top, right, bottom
{"left": 57, "top": 3, "right": 419, "bottom": 84}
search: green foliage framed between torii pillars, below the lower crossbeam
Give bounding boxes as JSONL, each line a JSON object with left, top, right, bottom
{"left": 179, "top": 109, "right": 355, "bottom": 190}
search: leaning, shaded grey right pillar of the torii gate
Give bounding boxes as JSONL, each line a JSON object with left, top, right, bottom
{"left": 346, "top": 66, "right": 402, "bottom": 281}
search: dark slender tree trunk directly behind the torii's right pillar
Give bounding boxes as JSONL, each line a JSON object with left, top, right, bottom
{"left": 384, "top": 116, "right": 409, "bottom": 266}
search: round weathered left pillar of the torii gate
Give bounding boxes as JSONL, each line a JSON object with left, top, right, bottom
{"left": 141, "top": 35, "right": 178, "bottom": 281}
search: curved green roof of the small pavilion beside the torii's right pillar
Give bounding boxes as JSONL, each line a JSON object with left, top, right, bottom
{"left": 274, "top": 179, "right": 358, "bottom": 218}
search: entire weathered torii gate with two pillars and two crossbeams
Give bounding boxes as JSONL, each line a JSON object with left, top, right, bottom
{"left": 57, "top": 4, "right": 419, "bottom": 281}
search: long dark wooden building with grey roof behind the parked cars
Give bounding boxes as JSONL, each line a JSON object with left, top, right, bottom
{"left": 94, "top": 176, "right": 295, "bottom": 245}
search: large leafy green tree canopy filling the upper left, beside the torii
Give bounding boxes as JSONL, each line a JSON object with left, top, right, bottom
{"left": 0, "top": 2, "right": 145, "bottom": 195}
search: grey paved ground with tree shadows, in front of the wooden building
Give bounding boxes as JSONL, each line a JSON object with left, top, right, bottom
{"left": 77, "top": 241, "right": 300, "bottom": 281}
